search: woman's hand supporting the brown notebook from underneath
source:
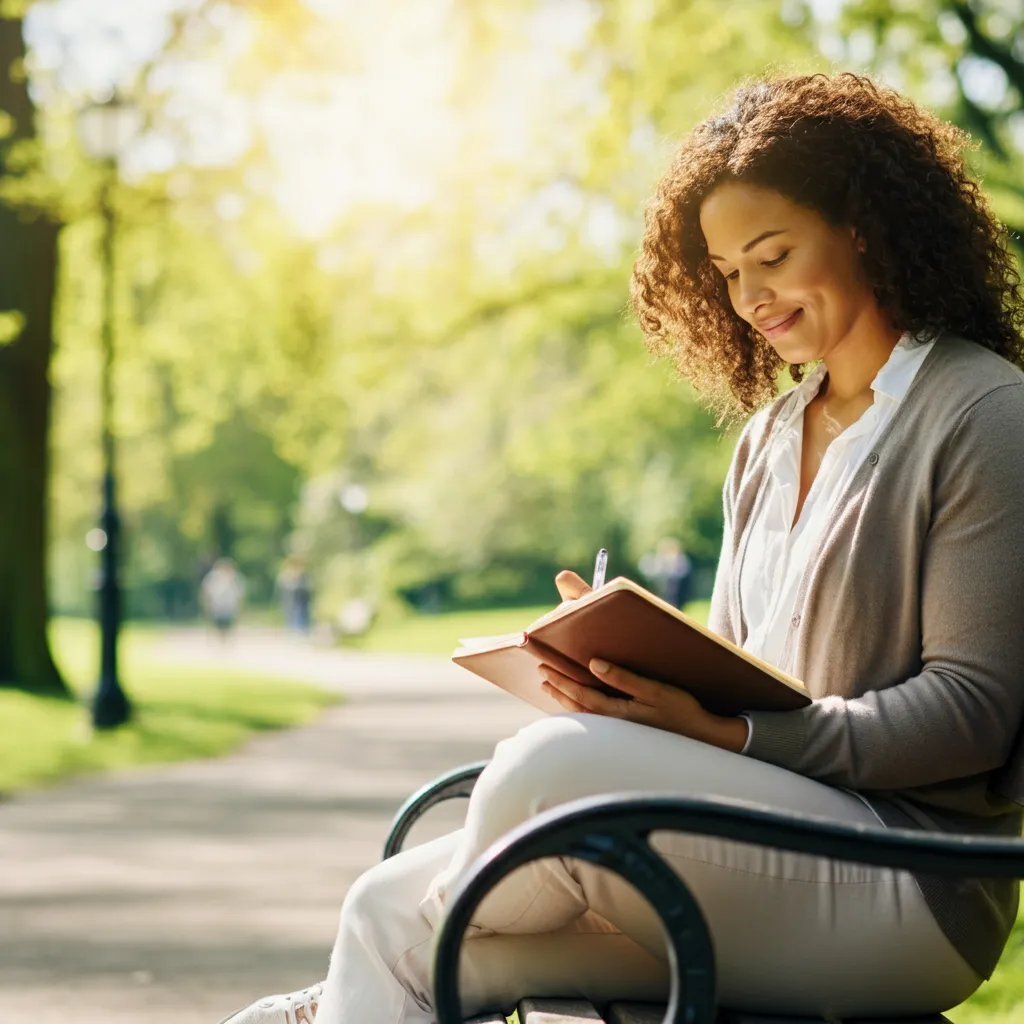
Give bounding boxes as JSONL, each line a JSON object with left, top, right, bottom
{"left": 541, "top": 658, "right": 748, "bottom": 754}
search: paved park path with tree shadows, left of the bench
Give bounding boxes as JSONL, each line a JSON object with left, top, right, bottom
{"left": 0, "top": 630, "right": 537, "bottom": 1024}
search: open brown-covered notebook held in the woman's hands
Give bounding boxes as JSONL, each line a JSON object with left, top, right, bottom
{"left": 452, "top": 577, "right": 811, "bottom": 715}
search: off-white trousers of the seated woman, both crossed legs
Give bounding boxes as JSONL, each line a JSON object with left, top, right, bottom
{"left": 316, "top": 715, "right": 982, "bottom": 1024}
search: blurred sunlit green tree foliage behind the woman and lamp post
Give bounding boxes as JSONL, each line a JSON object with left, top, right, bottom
{"left": 32, "top": 0, "right": 1024, "bottom": 618}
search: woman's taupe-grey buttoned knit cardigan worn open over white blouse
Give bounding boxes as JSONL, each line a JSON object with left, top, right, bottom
{"left": 710, "top": 333, "right": 1024, "bottom": 977}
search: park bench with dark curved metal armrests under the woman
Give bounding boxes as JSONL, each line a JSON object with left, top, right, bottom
{"left": 384, "top": 761, "right": 1024, "bottom": 1024}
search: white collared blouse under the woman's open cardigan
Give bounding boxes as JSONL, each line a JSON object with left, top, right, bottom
{"left": 738, "top": 332, "right": 935, "bottom": 749}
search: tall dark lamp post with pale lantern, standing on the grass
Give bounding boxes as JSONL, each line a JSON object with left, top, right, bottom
{"left": 78, "top": 95, "right": 139, "bottom": 729}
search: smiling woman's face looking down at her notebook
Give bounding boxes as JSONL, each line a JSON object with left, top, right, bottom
{"left": 700, "top": 181, "right": 879, "bottom": 364}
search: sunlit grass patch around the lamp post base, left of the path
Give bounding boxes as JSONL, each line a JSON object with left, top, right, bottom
{"left": 0, "top": 620, "right": 338, "bottom": 794}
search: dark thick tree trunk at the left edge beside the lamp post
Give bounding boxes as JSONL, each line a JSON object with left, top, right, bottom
{"left": 0, "top": 17, "right": 69, "bottom": 694}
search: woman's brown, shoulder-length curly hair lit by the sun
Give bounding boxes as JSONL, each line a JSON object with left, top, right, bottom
{"left": 630, "top": 73, "right": 1024, "bottom": 418}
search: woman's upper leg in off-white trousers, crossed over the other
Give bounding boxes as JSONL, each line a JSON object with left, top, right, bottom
{"left": 421, "top": 715, "right": 981, "bottom": 1016}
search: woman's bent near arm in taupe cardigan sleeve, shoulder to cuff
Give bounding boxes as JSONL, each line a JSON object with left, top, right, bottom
{"left": 746, "top": 385, "right": 1024, "bottom": 790}
